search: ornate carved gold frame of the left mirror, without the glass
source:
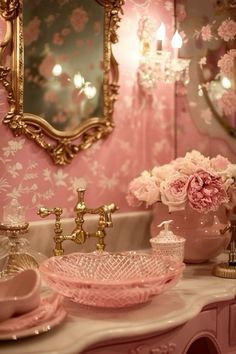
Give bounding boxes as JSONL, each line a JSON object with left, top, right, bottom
{"left": 0, "top": 0, "right": 124, "bottom": 165}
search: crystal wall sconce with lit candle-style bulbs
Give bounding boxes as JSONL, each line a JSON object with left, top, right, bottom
{"left": 138, "top": 16, "right": 190, "bottom": 89}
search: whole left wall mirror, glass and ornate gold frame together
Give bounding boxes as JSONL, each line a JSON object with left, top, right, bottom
{"left": 0, "top": 0, "right": 124, "bottom": 165}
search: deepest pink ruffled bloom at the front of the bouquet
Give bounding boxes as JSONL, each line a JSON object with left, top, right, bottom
{"left": 187, "top": 170, "right": 229, "bottom": 213}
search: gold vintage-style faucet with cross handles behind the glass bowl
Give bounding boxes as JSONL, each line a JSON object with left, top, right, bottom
{"left": 38, "top": 188, "right": 118, "bottom": 256}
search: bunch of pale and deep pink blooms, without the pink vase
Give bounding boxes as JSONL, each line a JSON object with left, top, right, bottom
{"left": 127, "top": 150, "right": 236, "bottom": 213}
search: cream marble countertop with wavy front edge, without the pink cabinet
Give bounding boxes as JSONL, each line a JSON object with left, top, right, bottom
{"left": 0, "top": 256, "right": 236, "bottom": 354}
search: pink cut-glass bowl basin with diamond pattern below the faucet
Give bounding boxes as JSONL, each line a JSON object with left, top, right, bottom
{"left": 40, "top": 252, "right": 184, "bottom": 308}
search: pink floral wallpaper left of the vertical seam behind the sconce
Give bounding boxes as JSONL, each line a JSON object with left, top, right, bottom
{"left": 0, "top": 0, "right": 174, "bottom": 220}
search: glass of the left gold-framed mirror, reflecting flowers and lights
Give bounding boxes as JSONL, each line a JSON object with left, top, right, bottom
{"left": 23, "top": 0, "right": 104, "bottom": 131}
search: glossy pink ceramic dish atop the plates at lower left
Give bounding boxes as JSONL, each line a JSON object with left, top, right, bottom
{"left": 0, "top": 269, "right": 41, "bottom": 321}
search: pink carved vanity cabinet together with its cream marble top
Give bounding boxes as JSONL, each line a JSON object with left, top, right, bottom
{"left": 0, "top": 255, "right": 236, "bottom": 354}
